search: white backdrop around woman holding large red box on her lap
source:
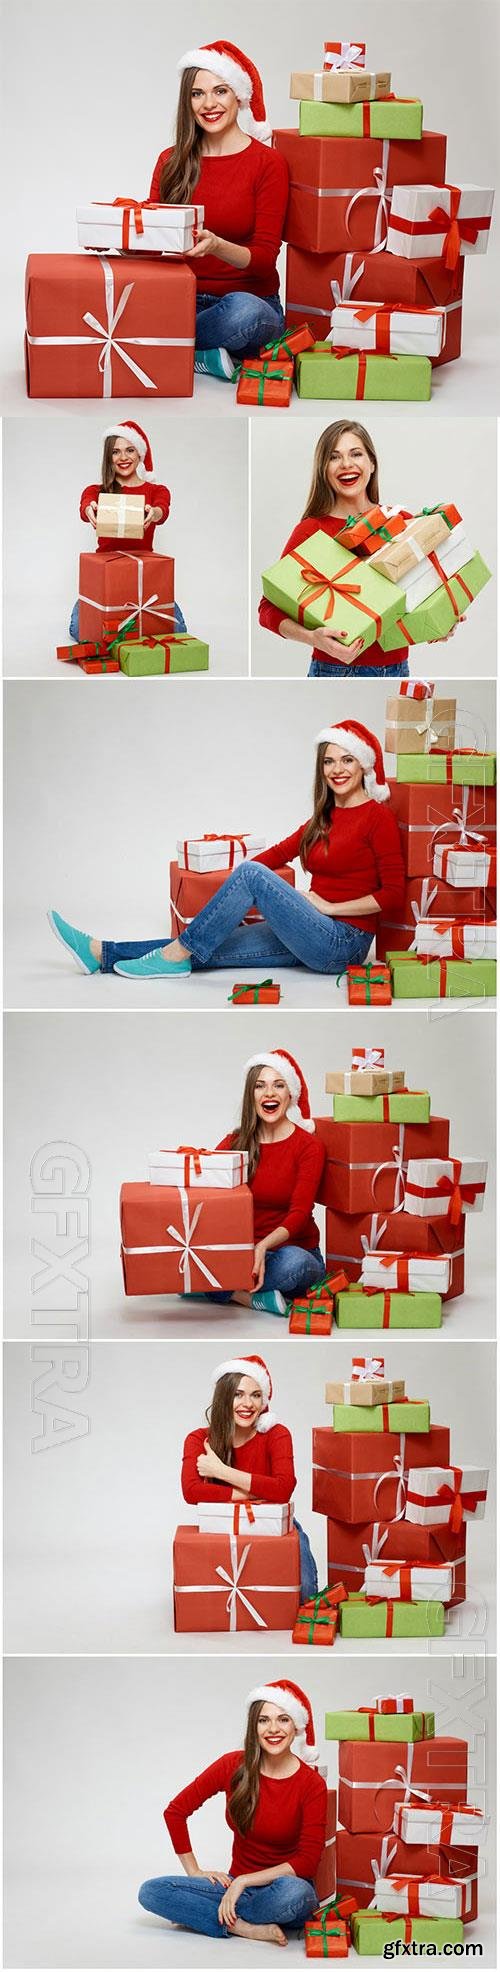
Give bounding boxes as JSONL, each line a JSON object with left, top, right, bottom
{"left": 4, "top": 1009, "right": 496, "bottom": 1369}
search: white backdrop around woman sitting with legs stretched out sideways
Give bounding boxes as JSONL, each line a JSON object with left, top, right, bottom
{"left": 4, "top": 678, "right": 494, "bottom": 1020}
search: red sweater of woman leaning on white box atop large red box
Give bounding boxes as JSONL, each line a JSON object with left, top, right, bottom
{"left": 181, "top": 1424, "right": 297, "bottom": 1507}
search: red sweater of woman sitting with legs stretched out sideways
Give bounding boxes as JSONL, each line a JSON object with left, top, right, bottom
{"left": 253, "top": 801, "right": 406, "bottom": 942}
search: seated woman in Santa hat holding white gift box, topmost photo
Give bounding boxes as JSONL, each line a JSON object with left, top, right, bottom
{"left": 150, "top": 41, "right": 287, "bottom": 383}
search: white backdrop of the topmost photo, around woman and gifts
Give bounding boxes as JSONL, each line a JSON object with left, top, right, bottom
{"left": 2, "top": 0, "right": 500, "bottom": 422}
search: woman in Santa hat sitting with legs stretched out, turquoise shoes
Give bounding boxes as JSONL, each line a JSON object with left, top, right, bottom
{"left": 49, "top": 720, "right": 404, "bottom": 978}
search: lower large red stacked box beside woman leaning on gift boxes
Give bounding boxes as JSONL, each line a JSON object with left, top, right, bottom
{"left": 327, "top": 1520, "right": 467, "bottom": 1603}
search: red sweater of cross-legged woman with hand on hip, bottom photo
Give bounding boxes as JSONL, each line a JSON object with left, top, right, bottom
{"left": 165, "top": 1753, "right": 327, "bottom": 1881}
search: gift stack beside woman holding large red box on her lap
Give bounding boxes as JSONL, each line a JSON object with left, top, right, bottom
{"left": 315, "top": 1047, "right": 486, "bottom": 1329}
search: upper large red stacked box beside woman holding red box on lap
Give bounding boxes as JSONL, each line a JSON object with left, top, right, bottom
{"left": 315, "top": 1116, "right": 449, "bottom": 1213}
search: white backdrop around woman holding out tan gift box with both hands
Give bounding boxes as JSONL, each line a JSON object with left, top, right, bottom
{"left": 4, "top": 416, "right": 248, "bottom": 690}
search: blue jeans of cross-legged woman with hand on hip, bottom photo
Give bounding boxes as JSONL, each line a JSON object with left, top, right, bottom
{"left": 140, "top": 1875, "right": 317, "bottom": 1938}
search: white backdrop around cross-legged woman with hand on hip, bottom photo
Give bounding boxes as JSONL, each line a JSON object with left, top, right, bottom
{"left": 6, "top": 1651, "right": 496, "bottom": 1972}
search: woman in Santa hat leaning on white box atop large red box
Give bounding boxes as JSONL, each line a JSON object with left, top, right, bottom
{"left": 181, "top": 1357, "right": 317, "bottom": 1601}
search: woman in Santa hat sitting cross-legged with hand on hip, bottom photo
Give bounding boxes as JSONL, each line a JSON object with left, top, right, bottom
{"left": 140, "top": 1678, "right": 327, "bottom": 1944}
